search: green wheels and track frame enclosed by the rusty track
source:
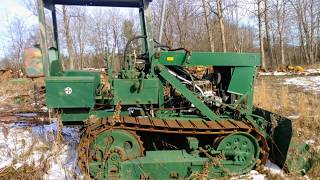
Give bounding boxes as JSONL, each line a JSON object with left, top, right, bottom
{"left": 89, "top": 130, "right": 260, "bottom": 180}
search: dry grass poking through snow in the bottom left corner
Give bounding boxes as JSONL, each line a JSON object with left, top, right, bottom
{"left": 0, "top": 117, "right": 65, "bottom": 180}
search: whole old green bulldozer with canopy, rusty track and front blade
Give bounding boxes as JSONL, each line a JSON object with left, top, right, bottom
{"left": 25, "top": 0, "right": 310, "bottom": 180}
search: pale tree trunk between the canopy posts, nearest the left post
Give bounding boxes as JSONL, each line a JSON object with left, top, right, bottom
{"left": 62, "top": 6, "right": 75, "bottom": 69}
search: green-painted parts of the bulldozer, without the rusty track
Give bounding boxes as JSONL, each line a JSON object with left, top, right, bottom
{"left": 38, "top": 0, "right": 305, "bottom": 180}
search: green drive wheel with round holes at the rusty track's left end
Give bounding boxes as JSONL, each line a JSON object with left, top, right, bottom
{"left": 79, "top": 129, "right": 144, "bottom": 179}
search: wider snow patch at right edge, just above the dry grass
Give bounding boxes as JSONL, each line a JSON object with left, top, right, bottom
{"left": 284, "top": 76, "right": 320, "bottom": 93}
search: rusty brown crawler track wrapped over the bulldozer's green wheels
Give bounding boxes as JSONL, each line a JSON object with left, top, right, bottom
{"left": 78, "top": 116, "right": 269, "bottom": 175}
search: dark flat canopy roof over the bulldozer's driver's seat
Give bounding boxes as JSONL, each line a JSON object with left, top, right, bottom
{"left": 43, "top": 0, "right": 152, "bottom": 9}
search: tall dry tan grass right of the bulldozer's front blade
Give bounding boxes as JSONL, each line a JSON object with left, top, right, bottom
{"left": 254, "top": 77, "right": 320, "bottom": 178}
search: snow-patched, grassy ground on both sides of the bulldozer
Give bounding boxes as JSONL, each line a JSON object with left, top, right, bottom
{"left": 0, "top": 74, "right": 320, "bottom": 179}
